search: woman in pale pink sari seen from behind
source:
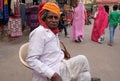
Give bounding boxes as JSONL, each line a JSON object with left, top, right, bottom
{"left": 71, "top": 2, "right": 85, "bottom": 42}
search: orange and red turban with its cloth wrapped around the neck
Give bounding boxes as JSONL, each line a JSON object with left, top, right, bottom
{"left": 38, "top": 2, "right": 60, "bottom": 34}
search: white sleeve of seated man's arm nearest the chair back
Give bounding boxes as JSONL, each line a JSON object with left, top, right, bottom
{"left": 26, "top": 28, "right": 55, "bottom": 78}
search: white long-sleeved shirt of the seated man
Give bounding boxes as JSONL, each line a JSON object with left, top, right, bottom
{"left": 27, "top": 26, "right": 64, "bottom": 81}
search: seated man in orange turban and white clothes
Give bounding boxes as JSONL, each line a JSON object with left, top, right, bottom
{"left": 26, "top": 2, "right": 91, "bottom": 81}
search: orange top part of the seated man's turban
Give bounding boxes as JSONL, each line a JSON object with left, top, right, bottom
{"left": 42, "top": 2, "right": 60, "bottom": 18}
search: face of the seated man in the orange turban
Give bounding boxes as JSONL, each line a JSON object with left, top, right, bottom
{"left": 45, "top": 12, "right": 59, "bottom": 29}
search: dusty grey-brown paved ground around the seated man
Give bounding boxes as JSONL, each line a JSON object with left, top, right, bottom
{"left": 0, "top": 21, "right": 120, "bottom": 81}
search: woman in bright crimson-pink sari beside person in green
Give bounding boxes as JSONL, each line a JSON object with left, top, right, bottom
{"left": 91, "top": 5, "right": 108, "bottom": 43}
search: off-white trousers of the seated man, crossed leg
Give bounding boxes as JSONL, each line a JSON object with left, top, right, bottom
{"left": 60, "top": 55, "right": 91, "bottom": 81}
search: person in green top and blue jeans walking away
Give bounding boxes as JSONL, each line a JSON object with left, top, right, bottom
{"left": 108, "top": 5, "right": 120, "bottom": 46}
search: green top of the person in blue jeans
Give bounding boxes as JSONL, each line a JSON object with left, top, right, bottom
{"left": 109, "top": 11, "right": 120, "bottom": 26}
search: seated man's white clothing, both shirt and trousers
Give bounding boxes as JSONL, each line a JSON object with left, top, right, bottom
{"left": 27, "top": 26, "right": 91, "bottom": 81}
